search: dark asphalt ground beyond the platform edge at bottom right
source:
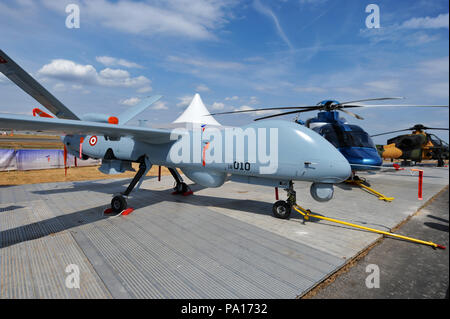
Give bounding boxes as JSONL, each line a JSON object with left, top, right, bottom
{"left": 313, "top": 189, "right": 449, "bottom": 299}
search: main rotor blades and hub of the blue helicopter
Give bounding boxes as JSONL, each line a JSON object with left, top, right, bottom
{"left": 206, "top": 97, "right": 448, "bottom": 121}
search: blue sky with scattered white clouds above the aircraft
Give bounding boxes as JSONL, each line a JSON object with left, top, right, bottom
{"left": 0, "top": 0, "right": 449, "bottom": 143}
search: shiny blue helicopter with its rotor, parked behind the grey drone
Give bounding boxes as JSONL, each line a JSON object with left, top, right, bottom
{"left": 211, "top": 97, "right": 446, "bottom": 175}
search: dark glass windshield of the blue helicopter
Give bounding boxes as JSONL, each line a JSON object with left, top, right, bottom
{"left": 314, "top": 124, "right": 375, "bottom": 148}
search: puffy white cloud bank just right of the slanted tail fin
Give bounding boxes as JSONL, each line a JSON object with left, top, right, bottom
{"left": 38, "top": 59, "right": 151, "bottom": 89}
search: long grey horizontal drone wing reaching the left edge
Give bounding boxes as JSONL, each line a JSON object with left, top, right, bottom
{"left": 0, "top": 114, "right": 182, "bottom": 144}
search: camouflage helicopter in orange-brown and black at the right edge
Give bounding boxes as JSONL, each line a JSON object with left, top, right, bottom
{"left": 371, "top": 124, "right": 449, "bottom": 167}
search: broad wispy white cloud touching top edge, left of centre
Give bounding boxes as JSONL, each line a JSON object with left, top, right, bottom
{"left": 43, "top": 0, "right": 237, "bottom": 39}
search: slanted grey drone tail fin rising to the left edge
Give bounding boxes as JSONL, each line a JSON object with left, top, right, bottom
{"left": 0, "top": 50, "right": 79, "bottom": 120}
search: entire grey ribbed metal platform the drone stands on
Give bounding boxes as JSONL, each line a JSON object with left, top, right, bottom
{"left": 0, "top": 168, "right": 449, "bottom": 298}
